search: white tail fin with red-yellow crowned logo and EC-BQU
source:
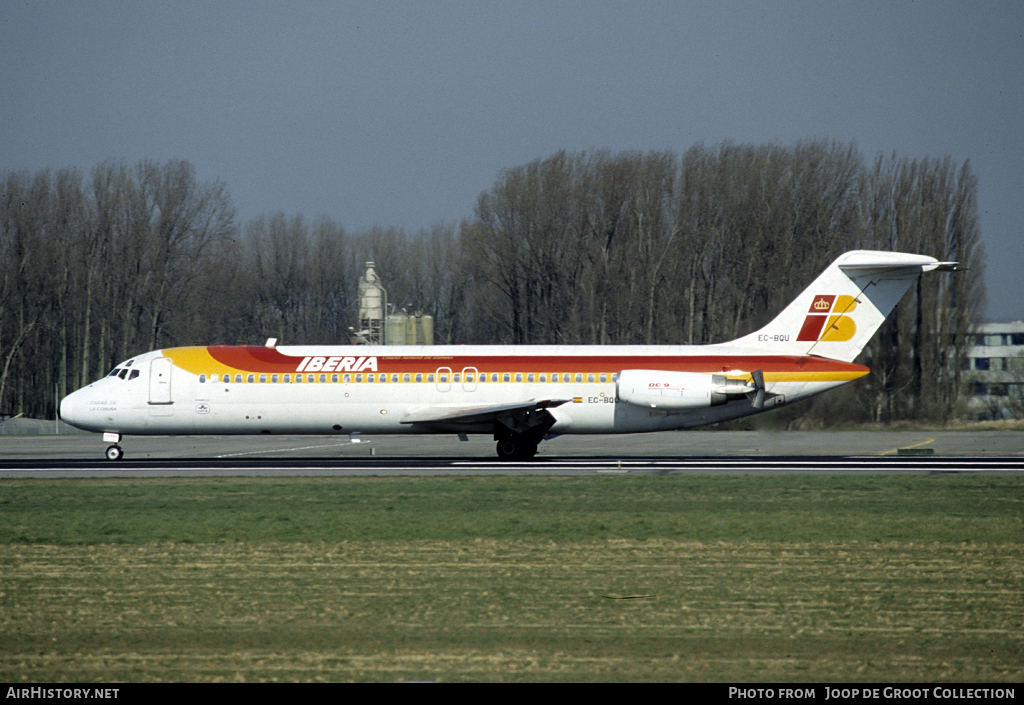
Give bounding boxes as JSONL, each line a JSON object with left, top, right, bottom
{"left": 733, "top": 250, "right": 956, "bottom": 362}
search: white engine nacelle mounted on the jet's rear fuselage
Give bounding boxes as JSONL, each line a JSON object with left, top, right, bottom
{"left": 617, "top": 370, "right": 755, "bottom": 411}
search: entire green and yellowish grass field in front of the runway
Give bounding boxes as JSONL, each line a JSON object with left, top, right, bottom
{"left": 0, "top": 475, "right": 1024, "bottom": 682}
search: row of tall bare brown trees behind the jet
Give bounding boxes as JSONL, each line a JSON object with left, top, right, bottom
{"left": 0, "top": 140, "right": 984, "bottom": 421}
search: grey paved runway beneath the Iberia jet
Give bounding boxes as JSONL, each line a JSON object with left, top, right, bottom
{"left": 0, "top": 431, "right": 1024, "bottom": 479}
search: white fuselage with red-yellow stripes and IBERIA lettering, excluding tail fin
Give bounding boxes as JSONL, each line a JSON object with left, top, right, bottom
{"left": 60, "top": 345, "right": 866, "bottom": 434}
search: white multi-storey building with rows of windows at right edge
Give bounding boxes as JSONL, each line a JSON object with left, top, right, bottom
{"left": 965, "top": 321, "right": 1024, "bottom": 419}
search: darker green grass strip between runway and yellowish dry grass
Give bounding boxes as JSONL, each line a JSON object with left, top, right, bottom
{"left": 0, "top": 475, "right": 1024, "bottom": 545}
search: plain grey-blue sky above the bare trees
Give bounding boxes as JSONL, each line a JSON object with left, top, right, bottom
{"left": 0, "top": 0, "right": 1024, "bottom": 320}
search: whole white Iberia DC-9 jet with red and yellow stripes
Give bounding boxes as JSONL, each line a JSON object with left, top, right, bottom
{"left": 59, "top": 250, "right": 956, "bottom": 460}
